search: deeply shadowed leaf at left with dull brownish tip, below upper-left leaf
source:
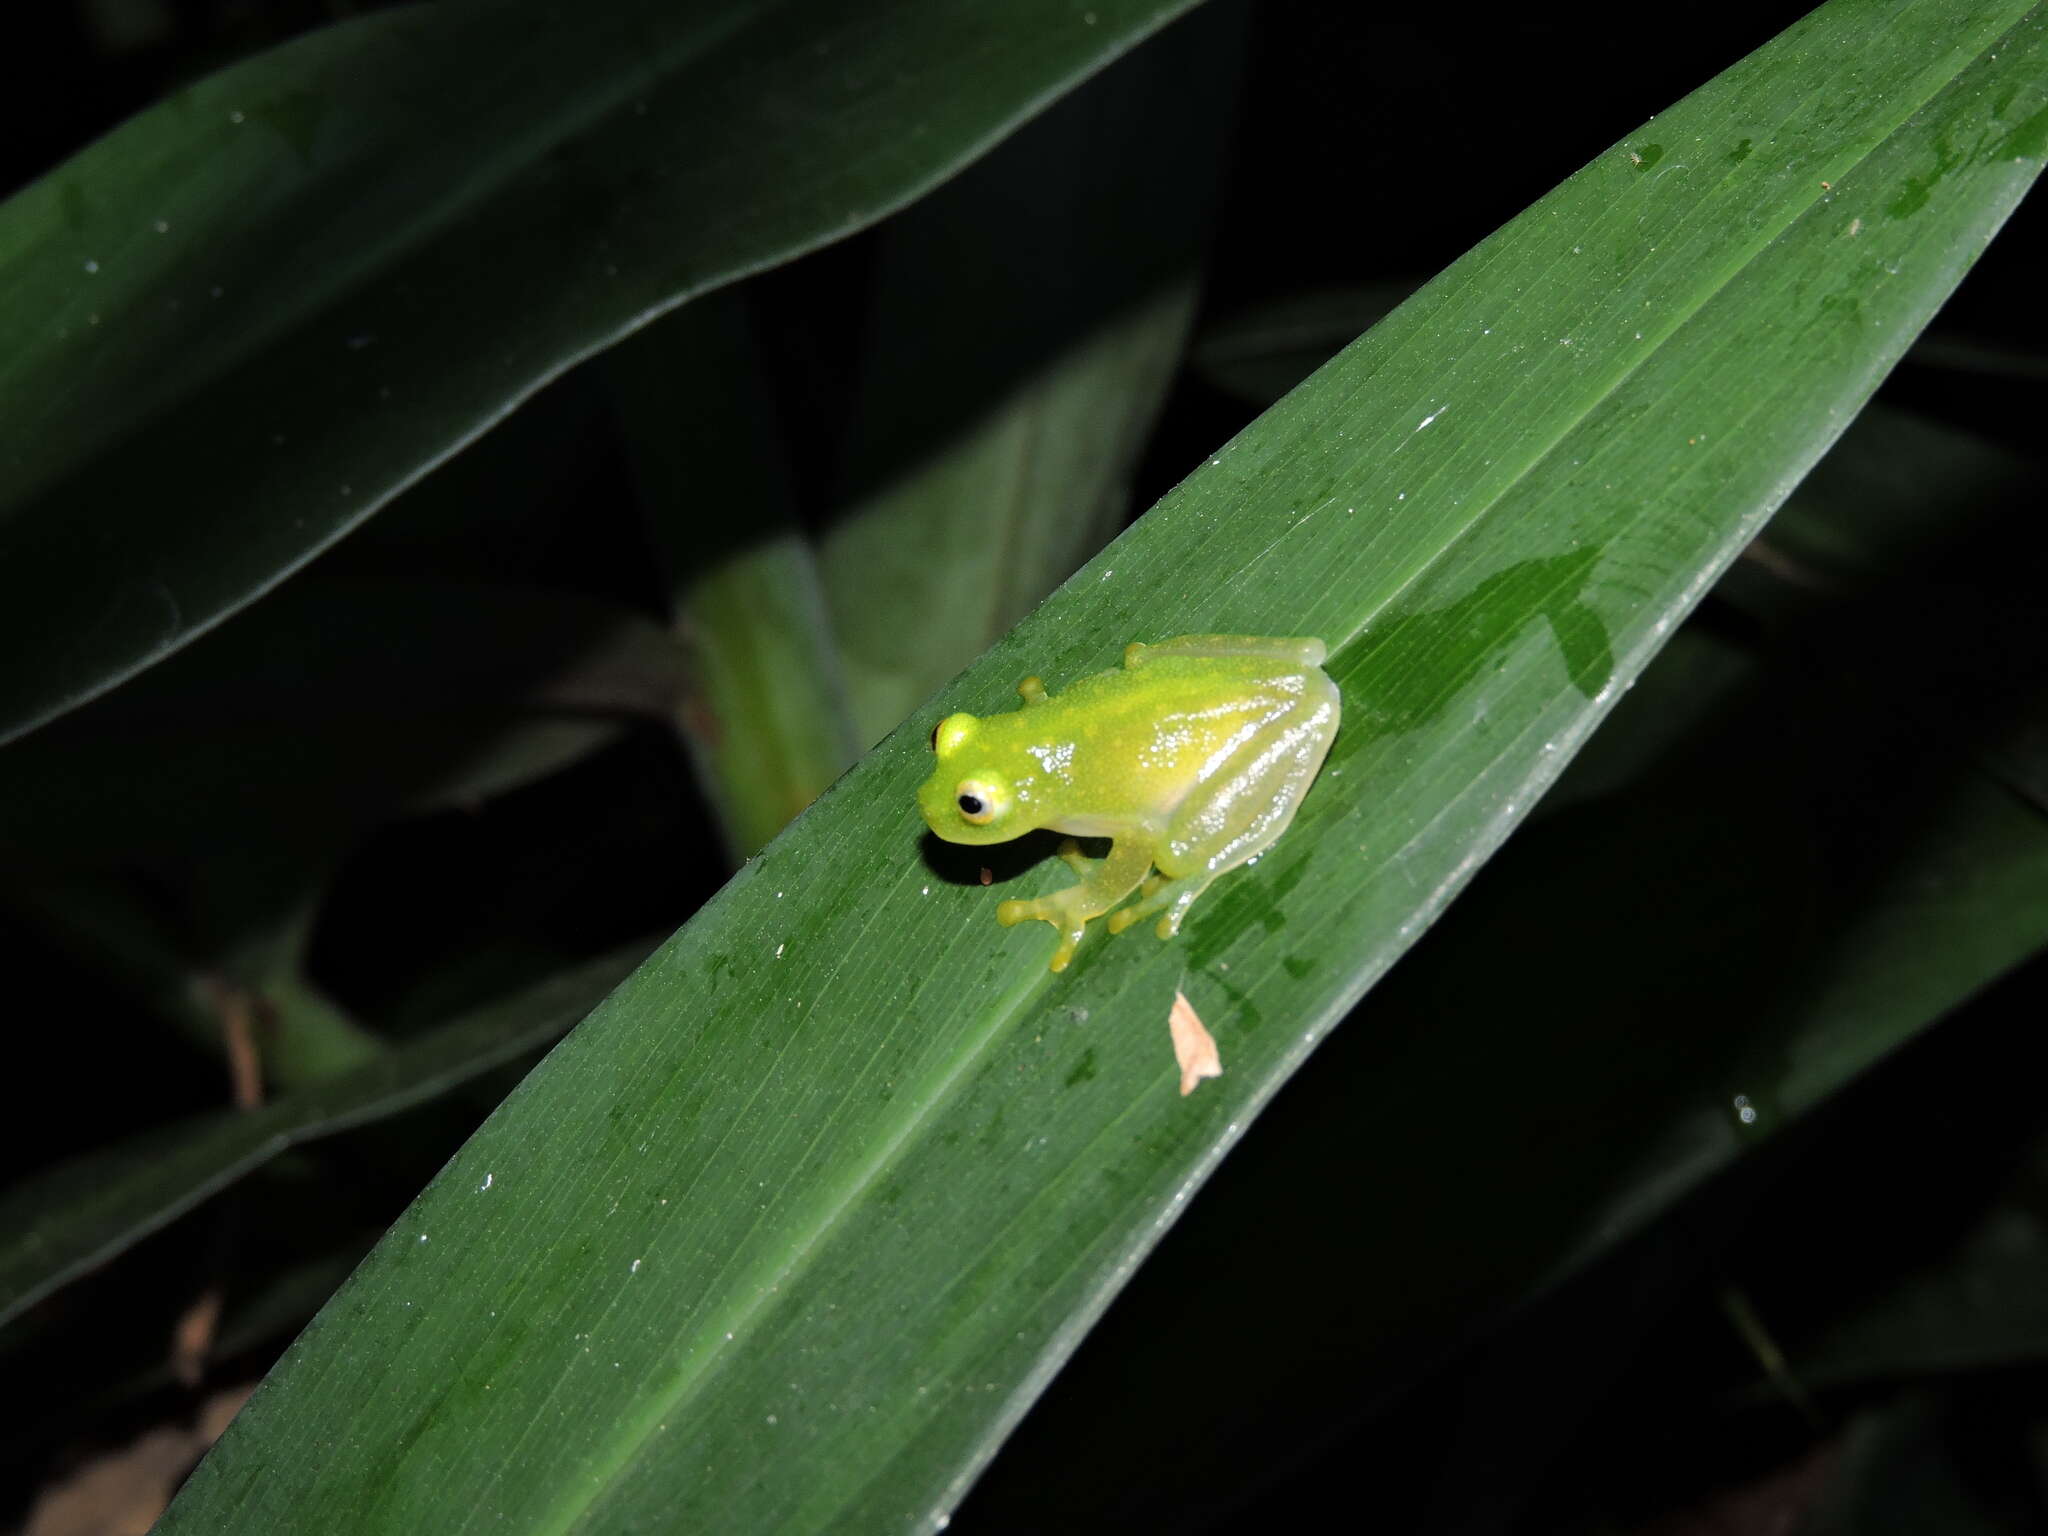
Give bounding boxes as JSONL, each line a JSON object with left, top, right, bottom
{"left": 0, "top": 580, "right": 682, "bottom": 870}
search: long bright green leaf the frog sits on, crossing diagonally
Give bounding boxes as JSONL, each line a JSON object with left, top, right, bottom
{"left": 151, "top": 0, "right": 2048, "bottom": 1532}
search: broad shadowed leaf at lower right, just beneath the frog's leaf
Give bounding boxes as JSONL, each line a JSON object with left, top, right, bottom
{"left": 969, "top": 634, "right": 2048, "bottom": 1532}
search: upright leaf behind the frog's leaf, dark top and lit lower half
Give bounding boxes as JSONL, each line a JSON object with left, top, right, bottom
{"left": 819, "top": 4, "right": 1245, "bottom": 745}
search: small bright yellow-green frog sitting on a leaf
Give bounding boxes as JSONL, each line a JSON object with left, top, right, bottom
{"left": 918, "top": 635, "right": 1339, "bottom": 971}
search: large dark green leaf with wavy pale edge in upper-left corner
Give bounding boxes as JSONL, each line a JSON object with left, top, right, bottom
{"left": 0, "top": 0, "right": 1192, "bottom": 739}
